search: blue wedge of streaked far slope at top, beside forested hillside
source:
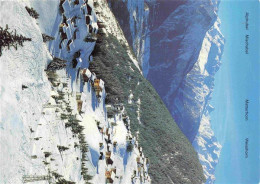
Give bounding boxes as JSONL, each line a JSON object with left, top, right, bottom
{"left": 108, "top": 0, "right": 150, "bottom": 76}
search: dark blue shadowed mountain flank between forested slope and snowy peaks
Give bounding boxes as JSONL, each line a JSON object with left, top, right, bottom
{"left": 147, "top": 1, "right": 220, "bottom": 131}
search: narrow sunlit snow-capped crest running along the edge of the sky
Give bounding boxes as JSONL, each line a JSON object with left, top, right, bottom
{"left": 187, "top": 19, "right": 224, "bottom": 184}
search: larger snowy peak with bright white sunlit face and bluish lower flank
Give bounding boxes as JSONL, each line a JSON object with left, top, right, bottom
{"left": 168, "top": 18, "right": 224, "bottom": 144}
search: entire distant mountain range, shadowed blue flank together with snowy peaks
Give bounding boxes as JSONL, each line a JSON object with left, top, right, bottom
{"left": 145, "top": 1, "right": 224, "bottom": 183}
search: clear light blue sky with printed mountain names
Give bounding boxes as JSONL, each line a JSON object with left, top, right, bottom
{"left": 211, "top": 0, "right": 260, "bottom": 184}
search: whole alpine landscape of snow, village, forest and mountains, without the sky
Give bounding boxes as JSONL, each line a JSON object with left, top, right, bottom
{"left": 0, "top": 0, "right": 213, "bottom": 184}
